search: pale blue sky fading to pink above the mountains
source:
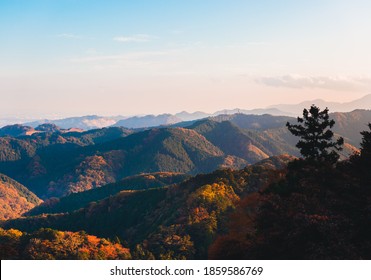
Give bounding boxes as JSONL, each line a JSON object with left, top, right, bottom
{"left": 0, "top": 0, "right": 371, "bottom": 117}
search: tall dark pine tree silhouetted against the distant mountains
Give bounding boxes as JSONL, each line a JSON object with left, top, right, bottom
{"left": 286, "top": 105, "right": 344, "bottom": 164}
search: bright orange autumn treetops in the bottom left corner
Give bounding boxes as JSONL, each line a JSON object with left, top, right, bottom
{"left": 0, "top": 228, "right": 131, "bottom": 260}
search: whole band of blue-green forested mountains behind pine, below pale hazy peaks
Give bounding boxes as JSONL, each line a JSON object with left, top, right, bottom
{"left": 0, "top": 110, "right": 371, "bottom": 199}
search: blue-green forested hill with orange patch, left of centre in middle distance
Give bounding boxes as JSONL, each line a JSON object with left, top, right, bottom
{"left": 0, "top": 128, "right": 246, "bottom": 198}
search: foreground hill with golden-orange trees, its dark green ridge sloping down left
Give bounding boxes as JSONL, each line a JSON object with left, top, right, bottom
{"left": 1, "top": 156, "right": 293, "bottom": 259}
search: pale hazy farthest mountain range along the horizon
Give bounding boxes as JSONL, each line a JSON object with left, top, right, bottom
{"left": 0, "top": 94, "right": 371, "bottom": 130}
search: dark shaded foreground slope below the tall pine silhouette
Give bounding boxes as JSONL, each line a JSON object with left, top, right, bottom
{"left": 209, "top": 119, "right": 371, "bottom": 259}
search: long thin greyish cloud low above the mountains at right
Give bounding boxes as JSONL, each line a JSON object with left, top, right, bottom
{"left": 255, "top": 75, "right": 371, "bottom": 91}
